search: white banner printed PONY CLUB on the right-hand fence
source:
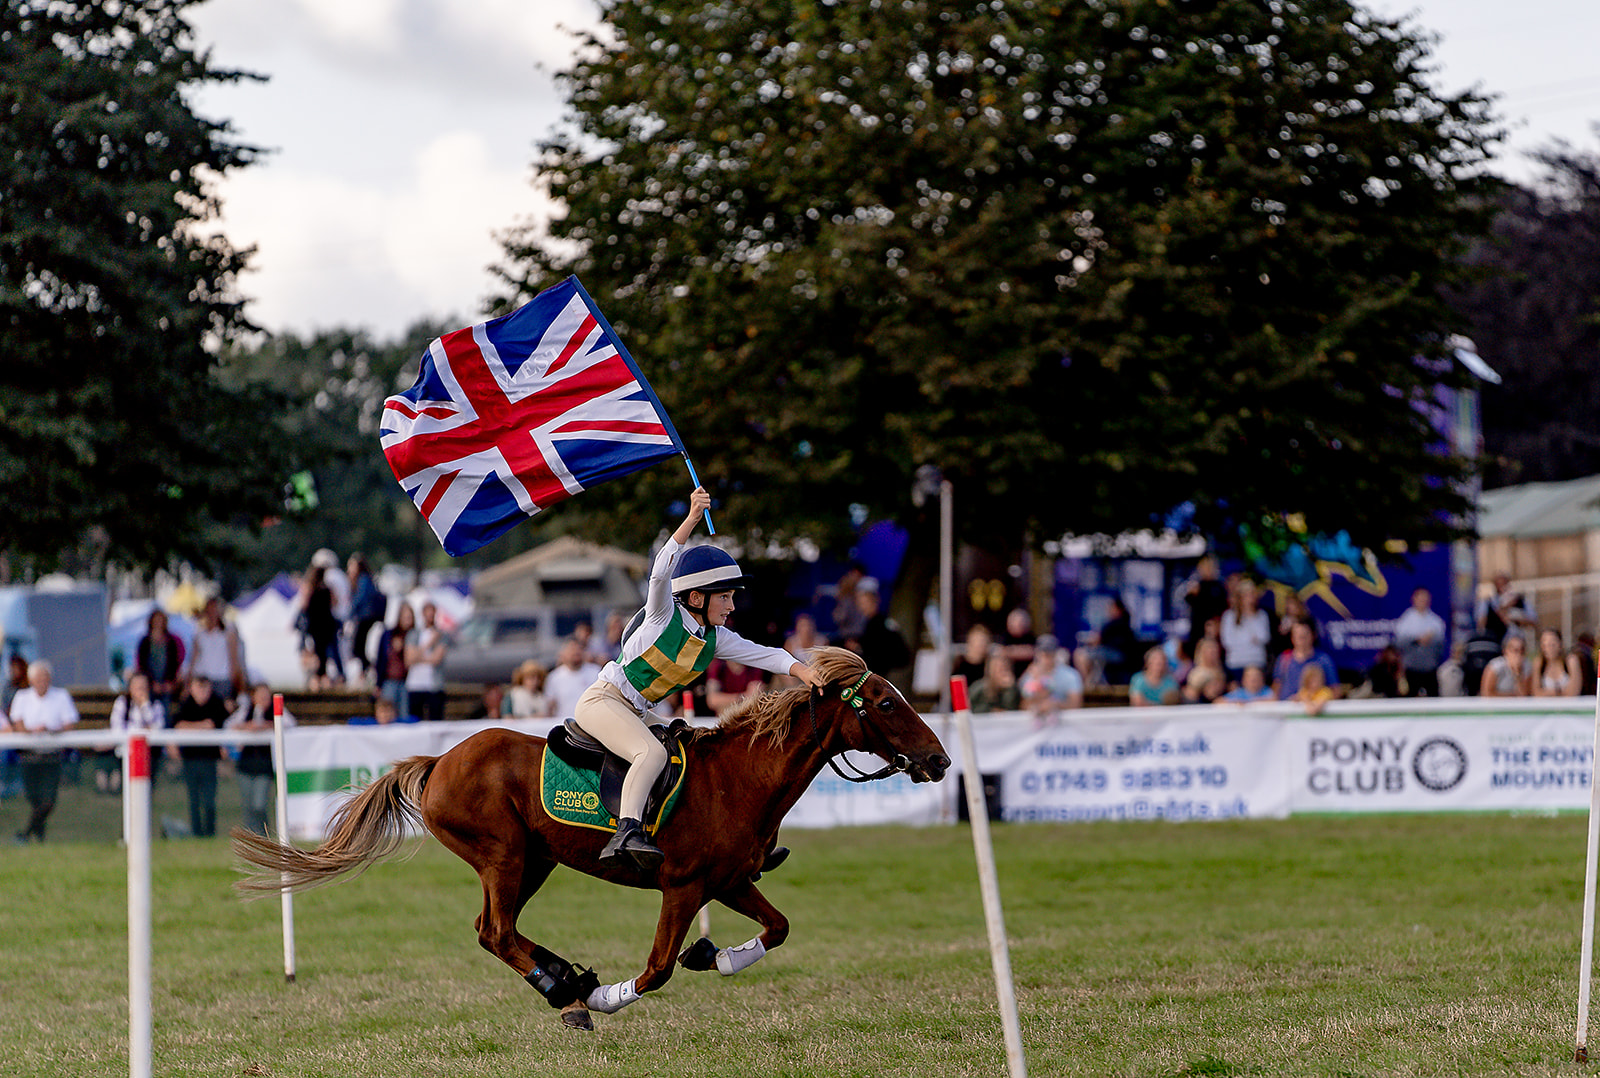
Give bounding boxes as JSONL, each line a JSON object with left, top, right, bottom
{"left": 1286, "top": 697, "right": 1595, "bottom": 812}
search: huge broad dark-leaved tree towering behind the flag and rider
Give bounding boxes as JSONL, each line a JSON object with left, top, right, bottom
{"left": 504, "top": 0, "right": 1499, "bottom": 566}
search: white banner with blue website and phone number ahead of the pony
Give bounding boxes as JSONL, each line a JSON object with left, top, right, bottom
{"left": 973, "top": 707, "right": 1290, "bottom": 822}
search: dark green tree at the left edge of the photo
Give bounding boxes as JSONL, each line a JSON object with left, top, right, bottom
{"left": 0, "top": 0, "right": 293, "bottom": 566}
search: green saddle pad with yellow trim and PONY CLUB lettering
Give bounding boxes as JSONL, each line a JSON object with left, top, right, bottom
{"left": 539, "top": 726, "right": 686, "bottom": 835}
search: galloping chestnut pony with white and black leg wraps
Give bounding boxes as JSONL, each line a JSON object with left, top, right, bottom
{"left": 234, "top": 648, "right": 950, "bottom": 1028}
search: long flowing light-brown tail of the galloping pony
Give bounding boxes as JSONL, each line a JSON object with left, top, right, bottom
{"left": 232, "top": 757, "right": 438, "bottom": 897}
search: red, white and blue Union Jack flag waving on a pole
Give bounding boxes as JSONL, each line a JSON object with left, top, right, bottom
{"left": 379, "top": 277, "right": 686, "bottom": 557}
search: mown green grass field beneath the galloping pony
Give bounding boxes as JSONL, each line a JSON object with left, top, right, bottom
{"left": 0, "top": 784, "right": 1600, "bottom": 1078}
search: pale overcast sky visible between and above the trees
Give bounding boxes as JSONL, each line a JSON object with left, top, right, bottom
{"left": 190, "top": 0, "right": 1600, "bottom": 339}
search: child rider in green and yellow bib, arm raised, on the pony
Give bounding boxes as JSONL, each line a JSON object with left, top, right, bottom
{"left": 573, "top": 488, "right": 822, "bottom": 868}
